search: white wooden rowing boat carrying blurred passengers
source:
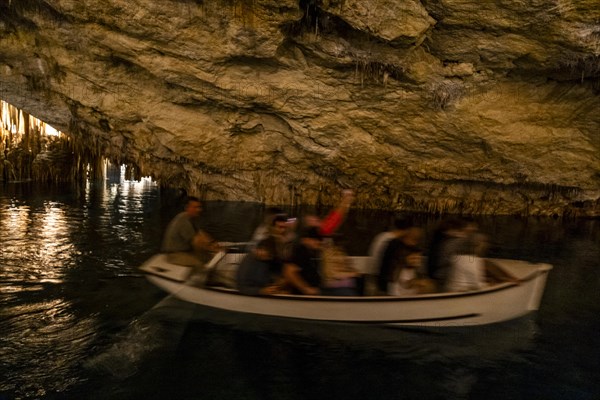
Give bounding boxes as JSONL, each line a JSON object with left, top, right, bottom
{"left": 140, "top": 253, "right": 552, "bottom": 327}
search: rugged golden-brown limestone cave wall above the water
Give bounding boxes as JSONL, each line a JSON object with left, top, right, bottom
{"left": 0, "top": 0, "right": 600, "bottom": 216}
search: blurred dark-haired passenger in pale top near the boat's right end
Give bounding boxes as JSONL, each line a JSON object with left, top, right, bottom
{"left": 445, "top": 233, "right": 487, "bottom": 292}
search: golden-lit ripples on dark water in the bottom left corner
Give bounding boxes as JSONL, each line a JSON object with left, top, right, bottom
{"left": 0, "top": 299, "right": 98, "bottom": 397}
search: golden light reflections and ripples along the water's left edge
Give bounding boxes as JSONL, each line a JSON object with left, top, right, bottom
{"left": 0, "top": 196, "right": 99, "bottom": 398}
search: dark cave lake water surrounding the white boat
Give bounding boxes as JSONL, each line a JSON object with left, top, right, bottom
{"left": 0, "top": 177, "right": 600, "bottom": 400}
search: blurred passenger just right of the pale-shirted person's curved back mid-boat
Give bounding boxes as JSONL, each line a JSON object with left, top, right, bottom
{"left": 388, "top": 246, "right": 434, "bottom": 296}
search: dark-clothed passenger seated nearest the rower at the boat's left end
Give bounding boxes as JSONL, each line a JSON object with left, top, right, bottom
{"left": 237, "top": 238, "right": 286, "bottom": 295}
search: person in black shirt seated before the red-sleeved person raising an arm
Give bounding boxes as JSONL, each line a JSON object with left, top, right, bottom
{"left": 283, "top": 227, "right": 322, "bottom": 295}
